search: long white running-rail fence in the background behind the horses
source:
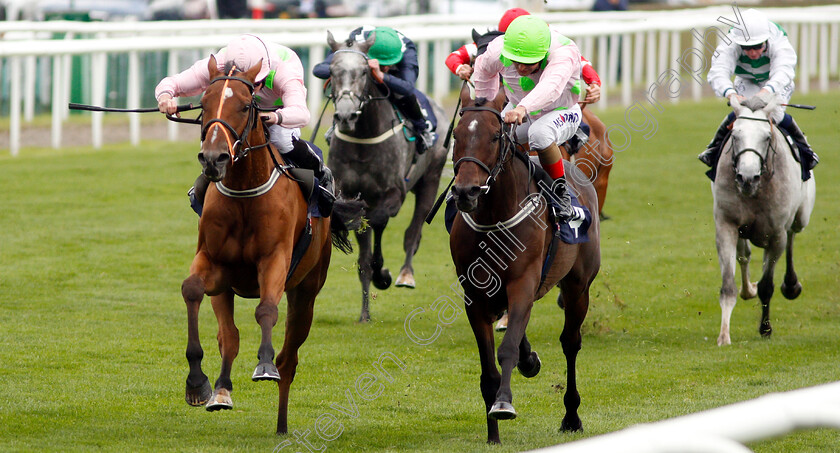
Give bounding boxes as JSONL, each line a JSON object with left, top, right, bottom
{"left": 0, "top": 5, "right": 840, "bottom": 155}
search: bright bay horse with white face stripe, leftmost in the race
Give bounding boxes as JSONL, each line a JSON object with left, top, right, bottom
{"left": 181, "top": 57, "right": 361, "bottom": 434}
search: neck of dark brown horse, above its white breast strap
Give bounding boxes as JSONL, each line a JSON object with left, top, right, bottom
{"left": 475, "top": 155, "right": 533, "bottom": 224}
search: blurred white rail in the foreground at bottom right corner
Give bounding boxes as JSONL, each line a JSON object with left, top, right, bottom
{"left": 534, "top": 381, "right": 840, "bottom": 453}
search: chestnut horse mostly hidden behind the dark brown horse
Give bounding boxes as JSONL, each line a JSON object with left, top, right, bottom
{"left": 560, "top": 104, "right": 615, "bottom": 220}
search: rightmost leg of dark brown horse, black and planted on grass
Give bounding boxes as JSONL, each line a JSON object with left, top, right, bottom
{"left": 560, "top": 277, "right": 589, "bottom": 431}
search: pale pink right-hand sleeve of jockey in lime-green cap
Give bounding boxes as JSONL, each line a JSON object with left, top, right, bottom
{"left": 519, "top": 46, "right": 580, "bottom": 112}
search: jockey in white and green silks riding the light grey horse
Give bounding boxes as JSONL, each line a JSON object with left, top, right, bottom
{"left": 697, "top": 9, "right": 819, "bottom": 178}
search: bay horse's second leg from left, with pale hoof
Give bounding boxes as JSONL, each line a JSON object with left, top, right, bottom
{"left": 205, "top": 291, "right": 239, "bottom": 412}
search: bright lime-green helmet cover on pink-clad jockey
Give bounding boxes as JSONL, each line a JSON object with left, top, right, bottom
{"left": 502, "top": 15, "right": 551, "bottom": 64}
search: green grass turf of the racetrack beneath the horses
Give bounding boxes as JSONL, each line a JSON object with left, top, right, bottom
{"left": 0, "top": 93, "right": 840, "bottom": 452}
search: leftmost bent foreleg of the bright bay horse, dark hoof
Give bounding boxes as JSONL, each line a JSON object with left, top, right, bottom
{"left": 181, "top": 252, "right": 213, "bottom": 406}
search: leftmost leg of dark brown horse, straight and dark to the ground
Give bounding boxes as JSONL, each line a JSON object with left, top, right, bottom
{"left": 467, "top": 304, "right": 501, "bottom": 444}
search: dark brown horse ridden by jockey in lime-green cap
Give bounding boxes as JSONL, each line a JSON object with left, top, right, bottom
{"left": 449, "top": 85, "right": 601, "bottom": 443}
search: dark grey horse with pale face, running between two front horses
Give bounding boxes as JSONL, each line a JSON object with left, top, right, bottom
{"left": 327, "top": 32, "right": 447, "bottom": 322}
